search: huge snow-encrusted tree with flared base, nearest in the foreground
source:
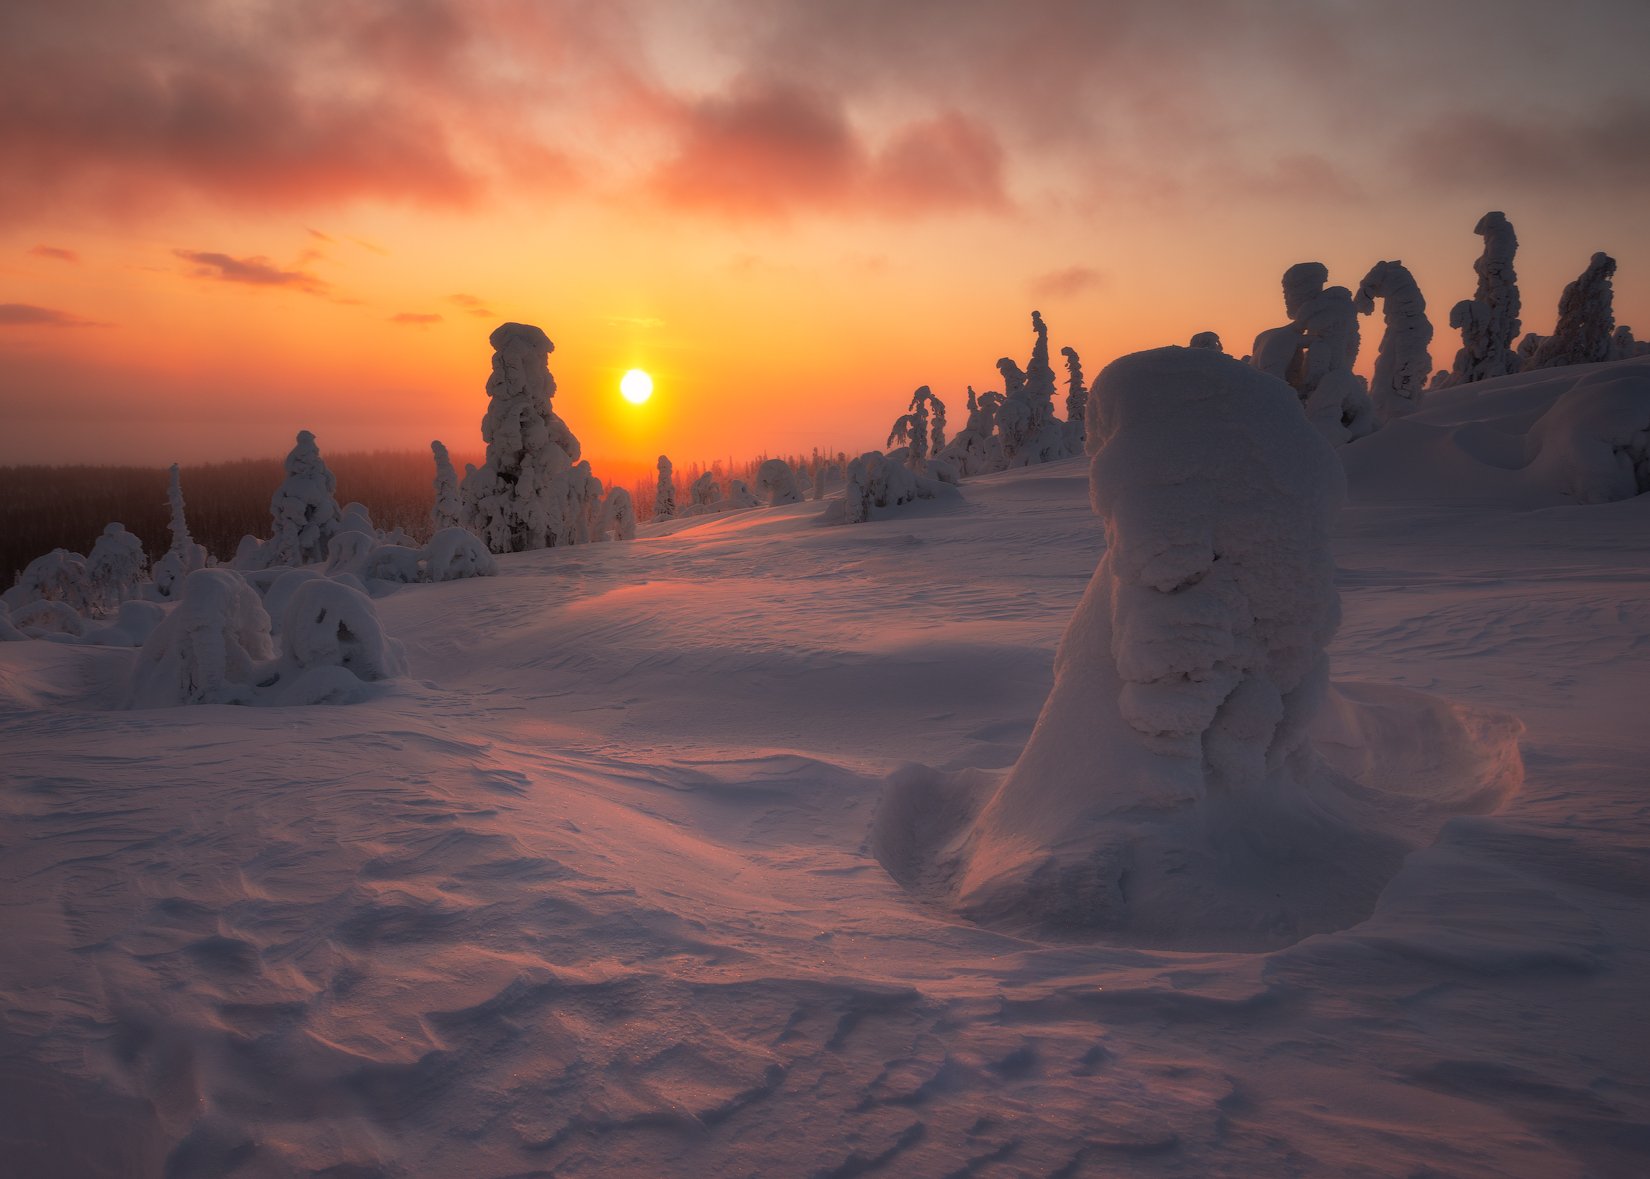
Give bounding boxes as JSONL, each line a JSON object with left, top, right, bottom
{"left": 954, "top": 348, "right": 1345, "bottom": 942}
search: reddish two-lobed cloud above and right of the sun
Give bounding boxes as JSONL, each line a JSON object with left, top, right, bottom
{"left": 648, "top": 78, "right": 1008, "bottom": 218}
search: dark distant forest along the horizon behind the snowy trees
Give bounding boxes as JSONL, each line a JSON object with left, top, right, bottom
{"left": 0, "top": 449, "right": 842, "bottom": 589}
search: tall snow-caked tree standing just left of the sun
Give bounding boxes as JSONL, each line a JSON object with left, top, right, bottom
{"left": 462, "top": 323, "right": 601, "bottom": 552}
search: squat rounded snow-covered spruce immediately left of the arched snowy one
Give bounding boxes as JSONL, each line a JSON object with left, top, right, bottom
{"left": 127, "top": 569, "right": 274, "bottom": 707}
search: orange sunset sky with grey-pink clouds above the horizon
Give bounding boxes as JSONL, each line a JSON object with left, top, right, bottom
{"left": 0, "top": 0, "right": 1650, "bottom": 473}
